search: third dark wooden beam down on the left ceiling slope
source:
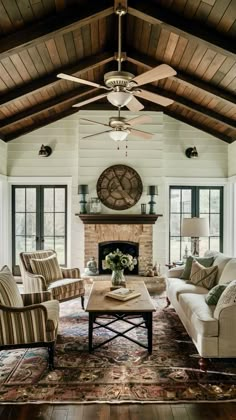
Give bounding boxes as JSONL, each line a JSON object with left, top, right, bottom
{"left": 0, "top": 87, "right": 101, "bottom": 129}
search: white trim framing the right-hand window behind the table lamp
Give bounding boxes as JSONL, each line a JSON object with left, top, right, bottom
{"left": 165, "top": 177, "right": 230, "bottom": 255}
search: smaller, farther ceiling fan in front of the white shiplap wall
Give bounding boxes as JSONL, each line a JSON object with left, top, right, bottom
{"left": 81, "top": 108, "right": 153, "bottom": 141}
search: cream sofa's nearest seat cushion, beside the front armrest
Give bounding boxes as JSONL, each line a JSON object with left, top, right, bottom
{"left": 179, "top": 293, "right": 219, "bottom": 337}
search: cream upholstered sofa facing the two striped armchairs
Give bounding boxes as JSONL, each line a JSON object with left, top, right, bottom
{"left": 166, "top": 251, "right": 236, "bottom": 368}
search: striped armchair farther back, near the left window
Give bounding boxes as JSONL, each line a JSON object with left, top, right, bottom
{"left": 20, "top": 249, "right": 85, "bottom": 309}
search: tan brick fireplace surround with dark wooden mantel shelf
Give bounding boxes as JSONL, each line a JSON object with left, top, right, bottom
{"left": 78, "top": 214, "right": 160, "bottom": 274}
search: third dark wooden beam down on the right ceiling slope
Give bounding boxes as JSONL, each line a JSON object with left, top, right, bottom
{"left": 140, "top": 85, "right": 236, "bottom": 129}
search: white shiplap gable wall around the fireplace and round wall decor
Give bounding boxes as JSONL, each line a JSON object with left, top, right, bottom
{"left": 5, "top": 111, "right": 228, "bottom": 267}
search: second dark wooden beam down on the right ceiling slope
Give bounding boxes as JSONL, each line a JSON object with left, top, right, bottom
{"left": 127, "top": 50, "right": 236, "bottom": 104}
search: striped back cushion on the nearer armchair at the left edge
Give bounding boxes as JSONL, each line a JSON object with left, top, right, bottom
{"left": 0, "top": 265, "right": 24, "bottom": 307}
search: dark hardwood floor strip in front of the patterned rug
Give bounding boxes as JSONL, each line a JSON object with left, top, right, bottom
{"left": 0, "top": 403, "right": 236, "bottom": 420}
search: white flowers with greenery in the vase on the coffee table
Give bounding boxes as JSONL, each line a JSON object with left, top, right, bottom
{"left": 105, "top": 249, "right": 137, "bottom": 271}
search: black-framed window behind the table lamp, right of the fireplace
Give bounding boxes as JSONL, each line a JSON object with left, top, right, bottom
{"left": 169, "top": 186, "right": 223, "bottom": 261}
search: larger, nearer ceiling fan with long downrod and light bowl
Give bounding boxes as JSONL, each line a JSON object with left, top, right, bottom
{"left": 57, "top": 6, "right": 176, "bottom": 112}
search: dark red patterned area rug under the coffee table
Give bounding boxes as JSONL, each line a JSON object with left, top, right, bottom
{"left": 0, "top": 296, "right": 236, "bottom": 403}
